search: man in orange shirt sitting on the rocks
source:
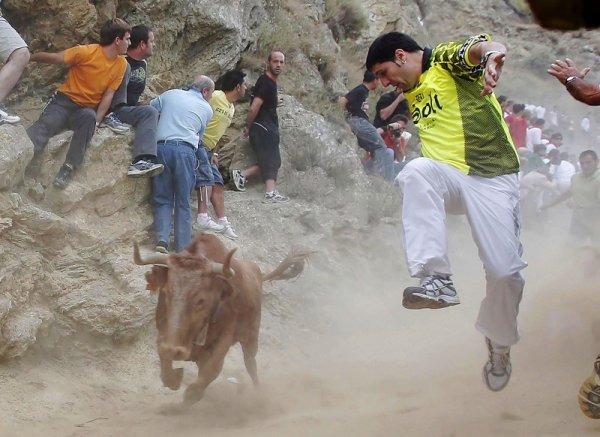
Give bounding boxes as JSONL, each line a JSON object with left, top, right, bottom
{"left": 26, "top": 18, "right": 131, "bottom": 188}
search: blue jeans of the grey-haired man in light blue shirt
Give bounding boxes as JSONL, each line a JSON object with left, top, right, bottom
{"left": 152, "top": 140, "right": 197, "bottom": 252}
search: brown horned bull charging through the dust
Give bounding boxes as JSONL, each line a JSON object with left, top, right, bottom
{"left": 133, "top": 234, "right": 309, "bottom": 404}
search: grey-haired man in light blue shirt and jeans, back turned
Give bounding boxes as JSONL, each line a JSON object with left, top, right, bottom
{"left": 150, "top": 76, "right": 215, "bottom": 253}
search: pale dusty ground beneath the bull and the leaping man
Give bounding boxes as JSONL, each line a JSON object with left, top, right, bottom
{"left": 0, "top": 209, "right": 600, "bottom": 437}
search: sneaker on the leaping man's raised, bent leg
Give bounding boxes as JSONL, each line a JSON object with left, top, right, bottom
{"left": 402, "top": 275, "right": 460, "bottom": 310}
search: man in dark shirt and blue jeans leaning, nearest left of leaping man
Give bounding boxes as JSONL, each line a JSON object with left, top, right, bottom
{"left": 338, "top": 71, "right": 394, "bottom": 180}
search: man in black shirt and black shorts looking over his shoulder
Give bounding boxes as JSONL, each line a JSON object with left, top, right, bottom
{"left": 232, "top": 50, "right": 289, "bottom": 202}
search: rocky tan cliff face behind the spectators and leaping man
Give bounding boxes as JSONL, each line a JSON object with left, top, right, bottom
{"left": 0, "top": 0, "right": 597, "bottom": 359}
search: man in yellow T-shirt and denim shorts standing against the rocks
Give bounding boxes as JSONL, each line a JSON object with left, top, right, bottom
{"left": 196, "top": 70, "right": 246, "bottom": 240}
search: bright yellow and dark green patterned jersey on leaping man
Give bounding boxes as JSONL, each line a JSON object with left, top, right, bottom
{"left": 404, "top": 34, "right": 519, "bottom": 177}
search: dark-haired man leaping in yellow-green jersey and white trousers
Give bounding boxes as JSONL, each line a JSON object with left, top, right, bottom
{"left": 366, "top": 32, "right": 527, "bottom": 391}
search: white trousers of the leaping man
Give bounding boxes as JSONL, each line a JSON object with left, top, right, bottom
{"left": 395, "top": 158, "right": 527, "bottom": 346}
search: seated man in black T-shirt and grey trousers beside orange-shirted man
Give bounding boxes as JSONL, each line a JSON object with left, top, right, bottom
{"left": 100, "top": 25, "right": 163, "bottom": 177}
